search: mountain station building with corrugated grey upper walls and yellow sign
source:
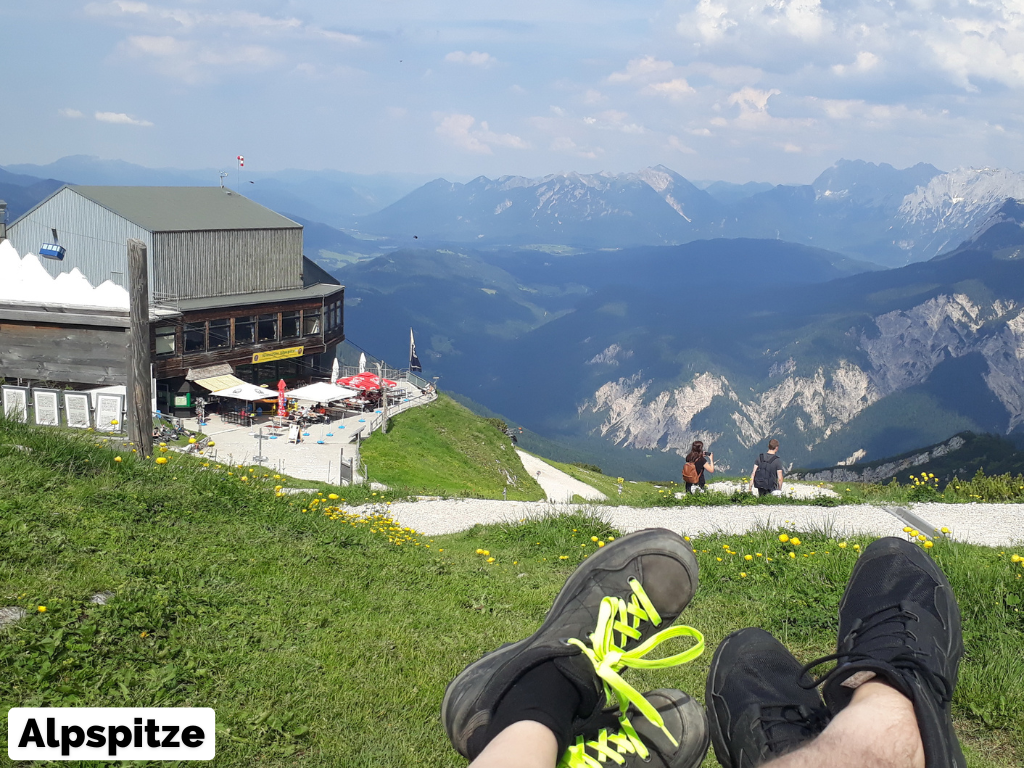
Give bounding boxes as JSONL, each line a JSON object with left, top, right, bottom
{"left": 0, "top": 185, "right": 345, "bottom": 413}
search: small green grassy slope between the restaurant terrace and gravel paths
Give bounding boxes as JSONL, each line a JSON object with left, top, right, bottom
{"left": 361, "top": 394, "right": 545, "bottom": 501}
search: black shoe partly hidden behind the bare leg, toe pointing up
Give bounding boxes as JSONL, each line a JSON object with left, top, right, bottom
{"left": 705, "top": 627, "right": 828, "bottom": 768}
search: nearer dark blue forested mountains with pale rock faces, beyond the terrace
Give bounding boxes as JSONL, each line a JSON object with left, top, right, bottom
{"left": 336, "top": 196, "right": 1024, "bottom": 477}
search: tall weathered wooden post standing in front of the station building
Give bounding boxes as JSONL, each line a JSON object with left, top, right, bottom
{"left": 127, "top": 239, "right": 153, "bottom": 459}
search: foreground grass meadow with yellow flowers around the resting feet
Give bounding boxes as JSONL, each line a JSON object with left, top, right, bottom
{"left": 0, "top": 423, "right": 1024, "bottom": 768}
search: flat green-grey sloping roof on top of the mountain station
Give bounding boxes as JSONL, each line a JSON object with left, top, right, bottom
{"left": 71, "top": 185, "right": 302, "bottom": 232}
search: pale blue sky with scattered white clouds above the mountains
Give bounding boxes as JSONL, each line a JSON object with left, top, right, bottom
{"left": 0, "top": 0, "right": 1024, "bottom": 183}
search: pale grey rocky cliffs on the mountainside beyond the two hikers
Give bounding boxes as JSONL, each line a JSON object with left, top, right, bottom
{"left": 578, "top": 293, "right": 1024, "bottom": 464}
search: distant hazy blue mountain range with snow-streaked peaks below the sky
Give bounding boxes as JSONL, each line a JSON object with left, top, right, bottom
{"left": 355, "top": 161, "right": 1024, "bottom": 266}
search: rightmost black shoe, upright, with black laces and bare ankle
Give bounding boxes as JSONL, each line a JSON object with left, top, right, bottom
{"left": 805, "top": 538, "right": 967, "bottom": 768}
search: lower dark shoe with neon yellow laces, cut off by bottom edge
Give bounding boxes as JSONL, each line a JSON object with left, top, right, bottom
{"left": 558, "top": 689, "right": 708, "bottom": 768}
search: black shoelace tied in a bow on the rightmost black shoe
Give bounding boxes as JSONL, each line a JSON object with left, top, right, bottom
{"left": 800, "top": 605, "right": 953, "bottom": 705}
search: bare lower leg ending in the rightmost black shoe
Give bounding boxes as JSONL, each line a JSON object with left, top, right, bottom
{"left": 766, "top": 681, "right": 925, "bottom": 768}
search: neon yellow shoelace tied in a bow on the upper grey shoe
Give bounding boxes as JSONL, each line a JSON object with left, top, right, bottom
{"left": 567, "top": 579, "right": 705, "bottom": 752}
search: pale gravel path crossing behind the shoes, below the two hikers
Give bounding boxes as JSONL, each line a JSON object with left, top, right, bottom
{"left": 391, "top": 499, "right": 1024, "bottom": 547}
